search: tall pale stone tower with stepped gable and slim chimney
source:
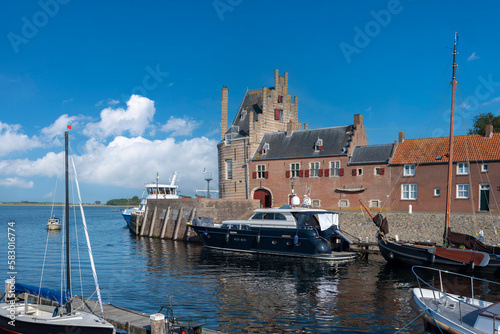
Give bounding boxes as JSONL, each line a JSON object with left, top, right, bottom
{"left": 217, "top": 69, "right": 301, "bottom": 199}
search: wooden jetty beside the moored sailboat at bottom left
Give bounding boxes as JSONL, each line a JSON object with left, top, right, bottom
{"left": 17, "top": 293, "right": 221, "bottom": 334}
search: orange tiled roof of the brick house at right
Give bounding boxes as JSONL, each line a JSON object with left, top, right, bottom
{"left": 391, "top": 133, "right": 500, "bottom": 165}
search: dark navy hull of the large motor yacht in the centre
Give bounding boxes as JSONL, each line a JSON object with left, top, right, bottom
{"left": 191, "top": 225, "right": 356, "bottom": 260}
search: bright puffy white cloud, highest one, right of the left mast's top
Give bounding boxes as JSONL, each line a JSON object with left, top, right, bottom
{"left": 84, "top": 95, "right": 155, "bottom": 138}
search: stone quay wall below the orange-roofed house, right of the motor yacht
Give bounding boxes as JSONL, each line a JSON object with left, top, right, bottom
{"left": 339, "top": 211, "right": 500, "bottom": 245}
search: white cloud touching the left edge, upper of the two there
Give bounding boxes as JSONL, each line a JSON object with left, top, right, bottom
{"left": 0, "top": 122, "right": 43, "bottom": 157}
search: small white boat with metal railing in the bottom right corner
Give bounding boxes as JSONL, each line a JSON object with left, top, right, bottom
{"left": 410, "top": 266, "right": 500, "bottom": 334}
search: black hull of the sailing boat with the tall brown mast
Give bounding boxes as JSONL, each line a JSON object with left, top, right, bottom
{"left": 378, "top": 234, "right": 500, "bottom": 274}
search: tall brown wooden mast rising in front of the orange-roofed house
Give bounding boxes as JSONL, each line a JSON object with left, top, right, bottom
{"left": 443, "top": 33, "right": 458, "bottom": 246}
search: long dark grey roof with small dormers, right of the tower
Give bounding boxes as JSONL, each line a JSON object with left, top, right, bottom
{"left": 253, "top": 125, "right": 353, "bottom": 160}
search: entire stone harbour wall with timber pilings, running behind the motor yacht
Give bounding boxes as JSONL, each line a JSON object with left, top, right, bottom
{"left": 131, "top": 198, "right": 500, "bottom": 245}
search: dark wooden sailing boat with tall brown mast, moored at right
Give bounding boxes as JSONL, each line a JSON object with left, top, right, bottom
{"left": 360, "top": 34, "right": 500, "bottom": 273}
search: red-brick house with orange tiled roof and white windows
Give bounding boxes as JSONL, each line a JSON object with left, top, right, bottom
{"left": 390, "top": 126, "right": 500, "bottom": 212}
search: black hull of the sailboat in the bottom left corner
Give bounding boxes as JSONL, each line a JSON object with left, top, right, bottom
{"left": 0, "top": 316, "right": 115, "bottom": 334}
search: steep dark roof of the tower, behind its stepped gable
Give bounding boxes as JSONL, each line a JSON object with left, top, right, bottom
{"left": 226, "top": 89, "right": 262, "bottom": 139}
